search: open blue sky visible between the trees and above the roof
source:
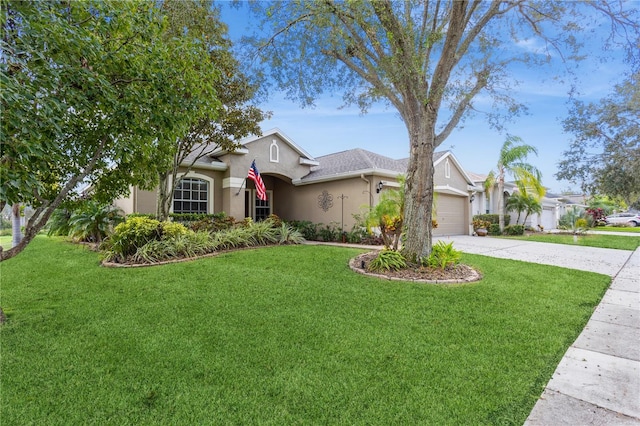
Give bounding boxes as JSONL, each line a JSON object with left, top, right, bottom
{"left": 222, "top": 1, "right": 623, "bottom": 193}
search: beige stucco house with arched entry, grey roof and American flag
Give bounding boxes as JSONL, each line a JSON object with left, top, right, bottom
{"left": 116, "top": 129, "right": 474, "bottom": 235}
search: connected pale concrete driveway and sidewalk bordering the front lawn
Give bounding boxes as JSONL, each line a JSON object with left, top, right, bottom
{"left": 438, "top": 235, "right": 640, "bottom": 426}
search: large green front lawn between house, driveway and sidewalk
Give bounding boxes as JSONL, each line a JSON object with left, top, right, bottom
{"left": 0, "top": 237, "right": 610, "bottom": 425}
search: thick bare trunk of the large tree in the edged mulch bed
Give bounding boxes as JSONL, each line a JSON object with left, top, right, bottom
{"left": 403, "top": 108, "right": 435, "bottom": 262}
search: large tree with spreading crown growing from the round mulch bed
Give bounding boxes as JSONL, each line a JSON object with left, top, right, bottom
{"left": 246, "top": 0, "right": 639, "bottom": 260}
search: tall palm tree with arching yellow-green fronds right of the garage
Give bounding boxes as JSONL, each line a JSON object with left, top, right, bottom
{"left": 484, "top": 135, "right": 545, "bottom": 231}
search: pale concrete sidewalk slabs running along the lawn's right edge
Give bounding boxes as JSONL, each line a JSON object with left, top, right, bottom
{"left": 525, "top": 249, "right": 640, "bottom": 426}
